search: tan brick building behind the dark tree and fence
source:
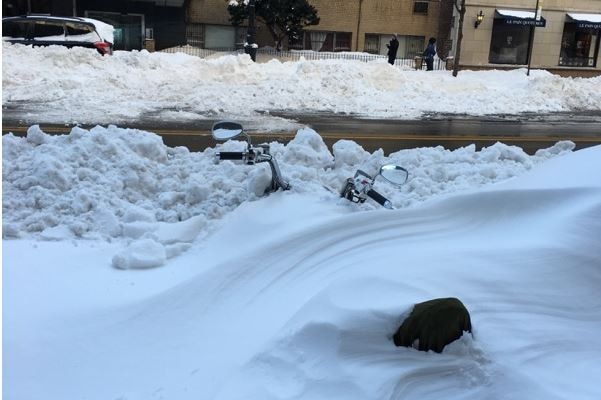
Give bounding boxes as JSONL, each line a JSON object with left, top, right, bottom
{"left": 187, "top": 0, "right": 440, "bottom": 58}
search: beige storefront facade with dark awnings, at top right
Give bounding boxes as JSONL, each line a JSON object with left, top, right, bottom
{"left": 455, "top": 0, "right": 601, "bottom": 76}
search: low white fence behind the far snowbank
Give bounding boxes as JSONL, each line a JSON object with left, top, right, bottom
{"left": 161, "top": 45, "right": 446, "bottom": 70}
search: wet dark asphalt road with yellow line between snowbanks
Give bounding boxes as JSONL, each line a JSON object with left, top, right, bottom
{"left": 2, "top": 109, "right": 601, "bottom": 154}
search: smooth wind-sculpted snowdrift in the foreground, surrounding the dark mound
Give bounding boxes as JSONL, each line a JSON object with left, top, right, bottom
{"left": 3, "top": 142, "right": 601, "bottom": 400}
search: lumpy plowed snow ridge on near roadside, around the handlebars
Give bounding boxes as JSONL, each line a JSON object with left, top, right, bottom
{"left": 2, "top": 125, "right": 574, "bottom": 243}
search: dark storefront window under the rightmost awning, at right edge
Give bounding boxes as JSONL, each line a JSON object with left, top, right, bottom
{"left": 559, "top": 22, "right": 600, "bottom": 67}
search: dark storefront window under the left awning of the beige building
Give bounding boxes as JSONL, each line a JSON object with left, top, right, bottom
{"left": 488, "top": 19, "right": 530, "bottom": 65}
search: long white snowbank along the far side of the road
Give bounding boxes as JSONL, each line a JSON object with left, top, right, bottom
{"left": 2, "top": 43, "right": 601, "bottom": 125}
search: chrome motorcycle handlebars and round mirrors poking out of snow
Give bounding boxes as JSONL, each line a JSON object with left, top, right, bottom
{"left": 212, "top": 121, "right": 409, "bottom": 209}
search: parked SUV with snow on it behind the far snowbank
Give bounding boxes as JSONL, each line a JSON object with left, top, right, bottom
{"left": 2, "top": 15, "right": 113, "bottom": 55}
